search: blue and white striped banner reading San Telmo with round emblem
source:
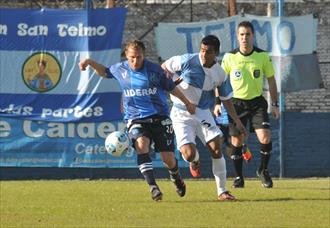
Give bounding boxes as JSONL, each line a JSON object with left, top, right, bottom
{"left": 0, "top": 8, "right": 127, "bottom": 122}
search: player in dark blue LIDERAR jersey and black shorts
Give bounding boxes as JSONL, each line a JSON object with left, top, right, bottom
{"left": 79, "top": 40, "right": 195, "bottom": 201}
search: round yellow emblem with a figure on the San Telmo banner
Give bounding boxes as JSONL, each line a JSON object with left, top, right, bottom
{"left": 22, "top": 52, "right": 62, "bottom": 93}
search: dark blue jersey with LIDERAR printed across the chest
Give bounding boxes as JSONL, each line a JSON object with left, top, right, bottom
{"left": 106, "top": 60, "right": 175, "bottom": 121}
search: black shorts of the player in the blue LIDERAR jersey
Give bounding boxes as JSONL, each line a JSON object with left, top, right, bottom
{"left": 128, "top": 115, "right": 175, "bottom": 152}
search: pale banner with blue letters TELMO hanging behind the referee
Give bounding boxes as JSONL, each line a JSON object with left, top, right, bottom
{"left": 155, "top": 15, "right": 322, "bottom": 92}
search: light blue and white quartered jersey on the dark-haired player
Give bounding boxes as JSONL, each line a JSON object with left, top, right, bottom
{"left": 165, "top": 53, "right": 233, "bottom": 109}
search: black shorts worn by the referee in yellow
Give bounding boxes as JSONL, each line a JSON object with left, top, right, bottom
{"left": 229, "top": 96, "right": 270, "bottom": 135}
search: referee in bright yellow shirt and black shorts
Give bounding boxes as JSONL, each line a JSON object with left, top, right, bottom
{"left": 216, "top": 21, "right": 279, "bottom": 188}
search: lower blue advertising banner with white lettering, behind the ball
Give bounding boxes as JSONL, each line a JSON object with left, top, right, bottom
{"left": 0, "top": 118, "right": 188, "bottom": 168}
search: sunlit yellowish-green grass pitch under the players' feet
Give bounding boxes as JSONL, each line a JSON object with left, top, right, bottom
{"left": 0, "top": 178, "right": 330, "bottom": 228}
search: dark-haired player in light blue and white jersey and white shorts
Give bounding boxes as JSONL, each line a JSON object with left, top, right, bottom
{"left": 162, "top": 35, "right": 245, "bottom": 200}
